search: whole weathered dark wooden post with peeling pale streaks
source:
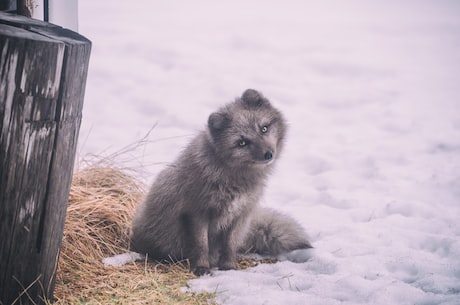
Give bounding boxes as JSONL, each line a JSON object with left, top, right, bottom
{"left": 0, "top": 12, "right": 91, "bottom": 305}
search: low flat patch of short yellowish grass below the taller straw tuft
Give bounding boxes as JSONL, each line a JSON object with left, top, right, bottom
{"left": 55, "top": 262, "right": 213, "bottom": 304}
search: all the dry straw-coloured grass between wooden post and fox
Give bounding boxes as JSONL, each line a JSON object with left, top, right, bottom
{"left": 54, "top": 163, "right": 213, "bottom": 304}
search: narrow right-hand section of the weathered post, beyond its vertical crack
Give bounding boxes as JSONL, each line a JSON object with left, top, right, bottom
{"left": 34, "top": 20, "right": 91, "bottom": 300}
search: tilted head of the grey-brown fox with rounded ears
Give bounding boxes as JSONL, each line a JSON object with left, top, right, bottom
{"left": 208, "top": 89, "right": 286, "bottom": 167}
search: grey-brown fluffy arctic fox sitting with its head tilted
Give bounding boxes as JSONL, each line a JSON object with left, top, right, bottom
{"left": 131, "top": 89, "right": 311, "bottom": 275}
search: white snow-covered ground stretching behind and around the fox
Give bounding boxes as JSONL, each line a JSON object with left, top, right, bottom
{"left": 79, "top": 0, "right": 460, "bottom": 305}
